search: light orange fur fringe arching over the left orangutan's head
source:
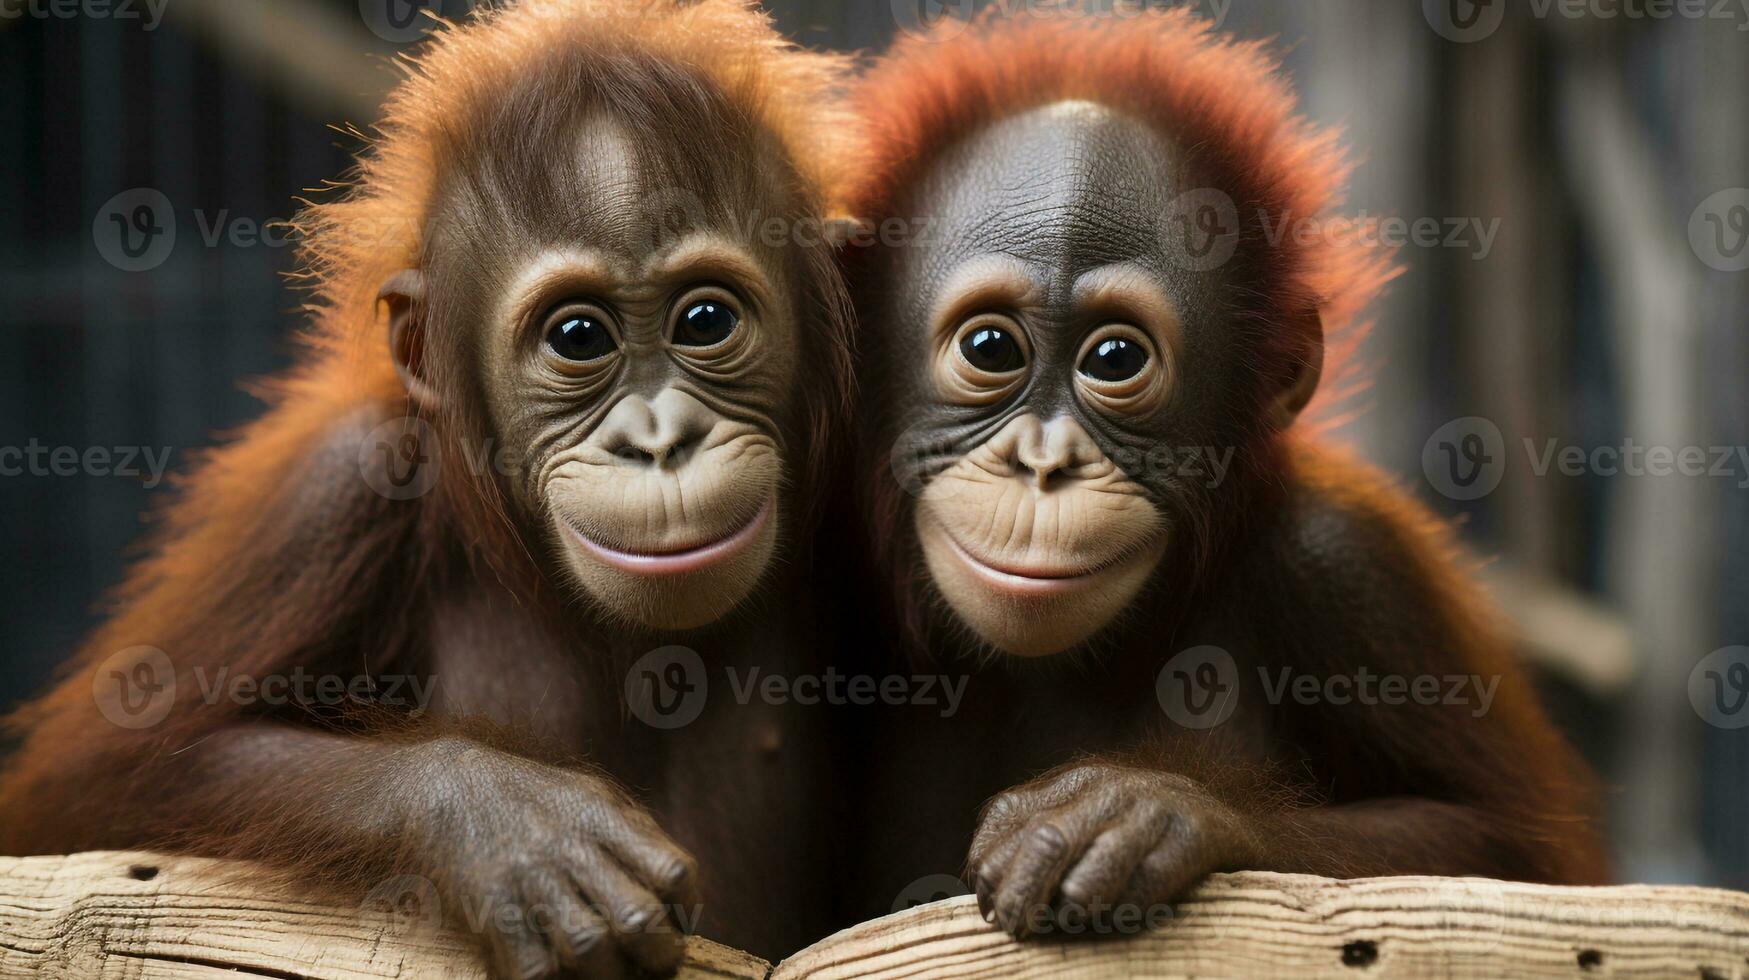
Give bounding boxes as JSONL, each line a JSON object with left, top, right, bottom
{"left": 296, "top": 0, "right": 847, "bottom": 383}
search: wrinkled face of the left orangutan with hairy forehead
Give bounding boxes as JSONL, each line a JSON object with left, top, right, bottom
{"left": 390, "top": 116, "right": 799, "bottom": 630}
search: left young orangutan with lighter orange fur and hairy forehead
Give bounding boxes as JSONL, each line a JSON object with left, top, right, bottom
{"left": 0, "top": 0, "right": 848, "bottom": 977}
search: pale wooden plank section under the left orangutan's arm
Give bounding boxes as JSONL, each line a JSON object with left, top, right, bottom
{"left": 0, "top": 851, "right": 770, "bottom": 980}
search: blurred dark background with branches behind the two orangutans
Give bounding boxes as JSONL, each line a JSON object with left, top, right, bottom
{"left": 0, "top": 0, "right": 1749, "bottom": 887}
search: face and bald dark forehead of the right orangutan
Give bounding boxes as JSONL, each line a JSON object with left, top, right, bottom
{"left": 885, "top": 103, "right": 1259, "bottom": 656}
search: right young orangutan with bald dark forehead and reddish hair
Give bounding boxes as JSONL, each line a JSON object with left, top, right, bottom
{"left": 845, "top": 11, "right": 1604, "bottom": 935}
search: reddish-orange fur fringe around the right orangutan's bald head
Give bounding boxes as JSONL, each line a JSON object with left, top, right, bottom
{"left": 834, "top": 9, "right": 1394, "bottom": 404}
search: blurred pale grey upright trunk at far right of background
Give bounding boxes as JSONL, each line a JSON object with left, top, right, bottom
{"left": 1557, "top": 25, "right": 1718, "bottom": 882}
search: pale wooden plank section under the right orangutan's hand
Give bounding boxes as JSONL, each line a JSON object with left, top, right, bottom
{"left": 771, "top": 873, "right": 1749, "bottom": 980}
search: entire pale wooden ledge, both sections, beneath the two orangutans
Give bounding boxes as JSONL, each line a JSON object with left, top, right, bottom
{"left": 0, "top": 852, "right": 1749, "bottom": 980}
